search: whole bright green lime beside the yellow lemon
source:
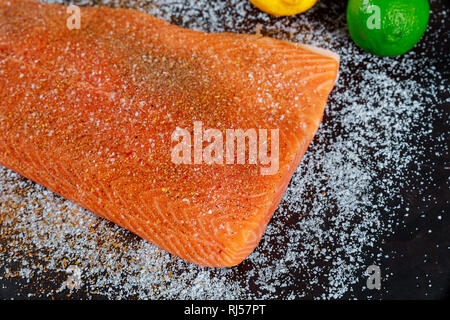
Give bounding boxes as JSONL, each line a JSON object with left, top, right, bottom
{"left": 347, "top": 0, "right": 430, "bottom": 56}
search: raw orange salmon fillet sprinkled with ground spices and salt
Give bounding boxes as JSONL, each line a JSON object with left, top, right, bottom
{"left": 0, "top": 0, "right": 339, "bottom": 267}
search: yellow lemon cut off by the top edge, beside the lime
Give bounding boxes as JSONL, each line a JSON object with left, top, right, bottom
{"left": 250, "top": 0, "right": 317, "bottom": 16}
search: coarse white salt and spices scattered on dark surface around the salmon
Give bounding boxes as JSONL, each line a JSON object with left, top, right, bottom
{"left": 0, "top": 0, "right": 449, "bottom": 299}
